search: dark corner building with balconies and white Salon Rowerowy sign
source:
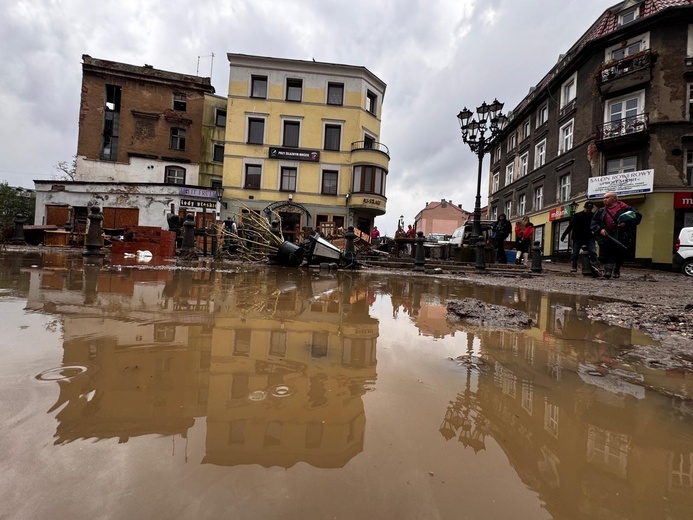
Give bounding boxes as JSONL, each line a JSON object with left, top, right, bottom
{"left": 489, "top": 0, "right": 693, "bottom": 266}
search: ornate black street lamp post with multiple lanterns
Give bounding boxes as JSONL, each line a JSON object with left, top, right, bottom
{"left": 457, "top": 99, "right": 508, "bottom": 269}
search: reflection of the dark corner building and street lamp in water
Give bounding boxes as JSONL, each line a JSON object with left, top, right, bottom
{"left": 441, "top": 295, "right": 693, "bottom": 519}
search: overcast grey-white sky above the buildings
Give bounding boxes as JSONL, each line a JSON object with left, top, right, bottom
{"left": 0, "top": 0, "right": 616, "bottom": 235}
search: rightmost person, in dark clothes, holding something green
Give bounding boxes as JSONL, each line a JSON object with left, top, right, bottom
{"left": 591, "top": 191, "right": 642, "bottom": 279}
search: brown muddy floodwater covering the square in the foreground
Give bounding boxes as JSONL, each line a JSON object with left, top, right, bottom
{"left": 0, "top": 252, "right": 693, "bottom": 520}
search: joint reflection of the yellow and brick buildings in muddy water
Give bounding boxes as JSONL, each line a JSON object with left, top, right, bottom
{"left": 21, "top": 263, "right": 378, "bottom": 467}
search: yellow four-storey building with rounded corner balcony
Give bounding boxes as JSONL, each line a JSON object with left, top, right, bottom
{"left": 223, "top": 53, "right": 390, "bottom": 240}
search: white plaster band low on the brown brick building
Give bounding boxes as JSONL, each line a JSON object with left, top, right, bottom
{"left": 76, "top": 156, "right": 200, "bottom": 185}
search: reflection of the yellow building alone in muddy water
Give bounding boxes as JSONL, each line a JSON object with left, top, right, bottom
{"left": 205, "top": 271, "right": 378, "bottom": 467}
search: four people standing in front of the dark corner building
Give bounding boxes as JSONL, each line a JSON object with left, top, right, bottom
{"left": 491, "top": 192, "right": 642, "bottom": 279}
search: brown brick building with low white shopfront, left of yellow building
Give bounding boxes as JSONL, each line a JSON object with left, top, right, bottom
{"left": 35, "top": 54, "right": 218, "bottom": 228}
